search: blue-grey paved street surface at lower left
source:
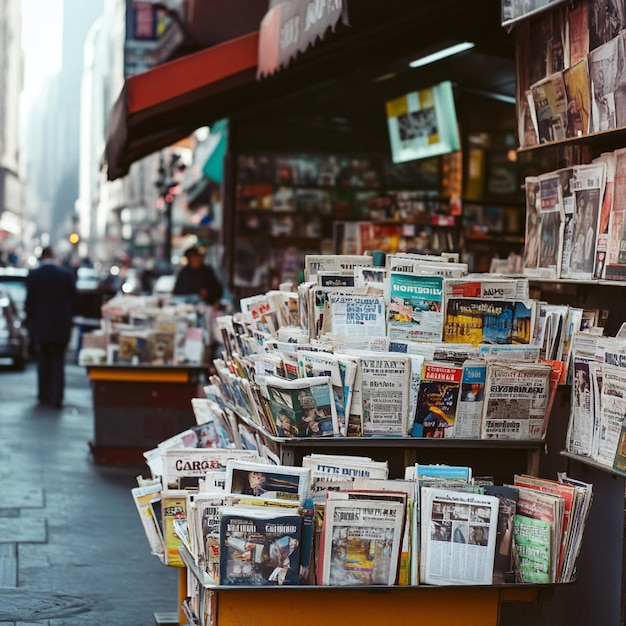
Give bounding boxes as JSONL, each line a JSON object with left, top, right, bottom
{"left": 0, "top": 356, "right": 179, "bottom": 626}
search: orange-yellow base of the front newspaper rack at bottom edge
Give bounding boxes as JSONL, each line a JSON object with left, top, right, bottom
{"left": 179, "top": 547, "right": 555, "bottom": 626}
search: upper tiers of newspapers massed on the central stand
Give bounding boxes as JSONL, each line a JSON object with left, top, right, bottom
{"left": 200, "top": 254, "right": 602, "bottom": 445}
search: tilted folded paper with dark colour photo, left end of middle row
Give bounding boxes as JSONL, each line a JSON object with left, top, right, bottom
{"left": 264, "top": 376, "right": 339, "bottom": 437}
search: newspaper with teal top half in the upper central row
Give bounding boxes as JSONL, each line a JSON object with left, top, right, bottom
{"left": 387, "top": 271, "right": 443, "bottom": 341}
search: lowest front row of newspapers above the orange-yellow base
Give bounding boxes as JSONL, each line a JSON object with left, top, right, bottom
{"left": 132, "top": 432, "right": 592, "bottom": 625}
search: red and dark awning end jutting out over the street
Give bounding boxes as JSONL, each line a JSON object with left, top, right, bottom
{"left": 105, "top": 32, "right": 259, "bottom": 180}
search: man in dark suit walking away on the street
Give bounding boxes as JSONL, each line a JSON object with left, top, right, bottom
{"left": 25, "top": 248, "right": 76, "bottom": 407}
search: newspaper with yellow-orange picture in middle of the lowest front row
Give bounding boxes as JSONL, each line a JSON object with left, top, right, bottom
{"left": 320, "top": 492, "right": 406, "bottom": 586}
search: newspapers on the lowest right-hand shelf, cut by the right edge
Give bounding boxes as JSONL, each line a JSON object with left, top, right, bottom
{"left": 567, "top": 328, "right": 626, "bottom": 472}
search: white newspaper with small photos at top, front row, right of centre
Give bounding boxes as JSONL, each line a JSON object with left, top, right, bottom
{"left": 420, "top": 487, "right": 499, "bottom": 585}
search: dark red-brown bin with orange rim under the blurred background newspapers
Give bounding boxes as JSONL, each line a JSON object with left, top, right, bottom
{"left": 87, "top": 365, "right": 208, "bottom": 464}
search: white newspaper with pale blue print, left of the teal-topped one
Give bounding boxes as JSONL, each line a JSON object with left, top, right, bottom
{"left": 323, "top": 293, "right": 387, "bottom": 337}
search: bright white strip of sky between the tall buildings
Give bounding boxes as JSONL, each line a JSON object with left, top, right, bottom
{"left": 22, "top": 0, "right": 62, "bottom": 100}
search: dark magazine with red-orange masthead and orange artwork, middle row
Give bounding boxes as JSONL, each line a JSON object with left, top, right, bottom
{"left": 411, "top": 361, "right": 463, "bottom": 439}
